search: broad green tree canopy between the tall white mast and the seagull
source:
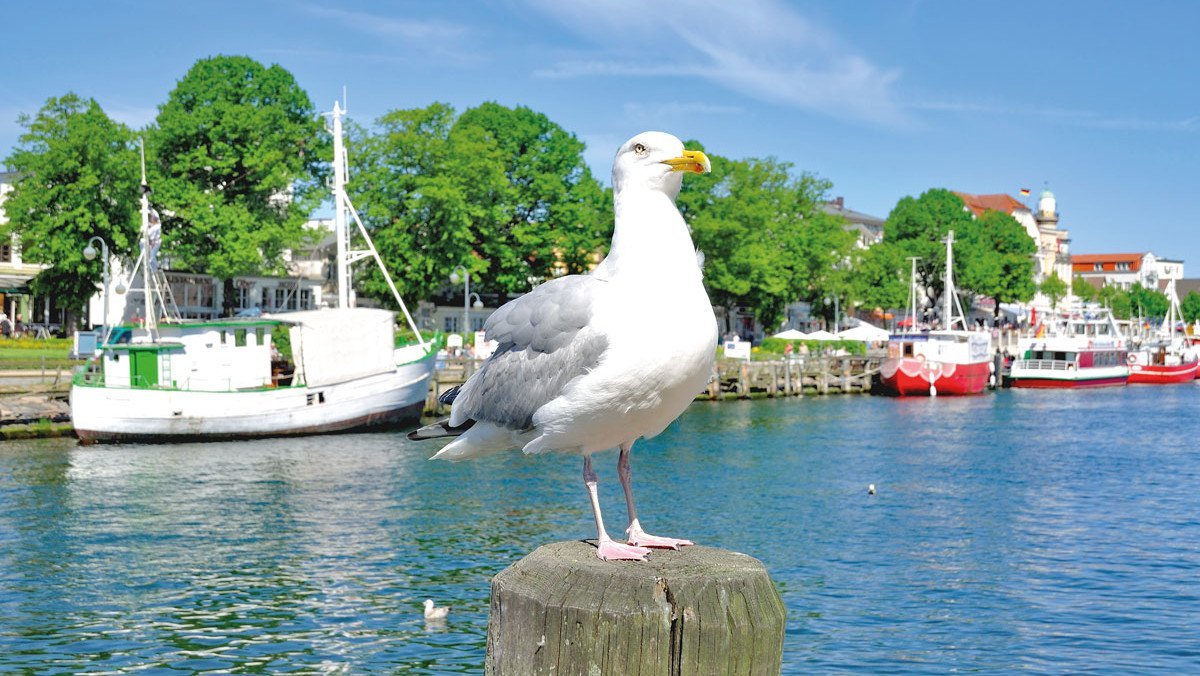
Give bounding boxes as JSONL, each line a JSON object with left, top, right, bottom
{"left": 349, "top": 103, "right": 612, "bottom": 303}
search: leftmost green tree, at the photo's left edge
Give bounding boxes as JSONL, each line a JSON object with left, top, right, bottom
{"left": 0, "top": 94, "right": 140, "bottom": 326}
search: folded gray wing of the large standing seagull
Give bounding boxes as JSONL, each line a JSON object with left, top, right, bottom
{"left": 450, "top": 275, "right": 608, "bottom": 431}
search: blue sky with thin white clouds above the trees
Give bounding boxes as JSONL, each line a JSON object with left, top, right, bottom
{"left": 0, "top": 0, "right": 1200, "bottom": 267}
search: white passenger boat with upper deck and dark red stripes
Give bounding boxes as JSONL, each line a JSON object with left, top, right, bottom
{"left": 1009, "top": 310, "right": 1129, "bottom": 388}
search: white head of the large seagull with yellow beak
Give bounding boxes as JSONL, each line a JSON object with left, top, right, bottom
{"left": 612, "top": 131, "right": 712, "bottom": 199}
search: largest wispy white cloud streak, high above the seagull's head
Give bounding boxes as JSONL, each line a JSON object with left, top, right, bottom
{"left": 526, "top": 0, "right": 906, "bottom": 125}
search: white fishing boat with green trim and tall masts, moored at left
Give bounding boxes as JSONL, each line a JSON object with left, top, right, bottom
{"left": 71, "top": 103, "right": 436, "bottom": 443}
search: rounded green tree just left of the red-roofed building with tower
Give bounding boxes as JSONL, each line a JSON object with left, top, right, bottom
{"left": 954, "top": 210, "right": 1038, "bottom": 317}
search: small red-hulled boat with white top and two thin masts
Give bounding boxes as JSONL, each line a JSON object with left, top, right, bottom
{"left": 880, "top": 231, "right": 994, "bottom": 396}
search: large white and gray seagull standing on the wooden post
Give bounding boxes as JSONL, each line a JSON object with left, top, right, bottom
{"left": 409, "top": 132, "right": 716, "bottom": 561}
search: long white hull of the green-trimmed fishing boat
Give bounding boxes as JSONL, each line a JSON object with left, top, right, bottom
{"left": 71, "top": 355, "right": 433, "bottom": 444}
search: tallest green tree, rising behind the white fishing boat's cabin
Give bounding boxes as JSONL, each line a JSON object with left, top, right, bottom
{"left": 150, "top": 56, "right": 330, "bottom": 312}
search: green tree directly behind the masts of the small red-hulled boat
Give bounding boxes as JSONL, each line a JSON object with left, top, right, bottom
{"left": 883, "top": 187, "right": 974, "bottom": 301}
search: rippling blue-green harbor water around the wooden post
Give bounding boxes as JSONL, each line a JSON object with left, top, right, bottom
{"left": 0, "top": 385, "right": 1200, "bottom": 674}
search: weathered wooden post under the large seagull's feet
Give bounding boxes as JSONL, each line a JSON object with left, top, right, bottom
{"left": 485, "top": 542, "right": 787, "bottom": 676}
